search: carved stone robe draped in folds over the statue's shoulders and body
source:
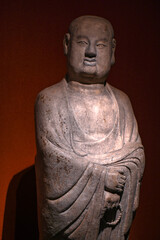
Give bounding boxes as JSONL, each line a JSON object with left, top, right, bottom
{"left": 35, "top": 79, "right": 144, "bottom": 240}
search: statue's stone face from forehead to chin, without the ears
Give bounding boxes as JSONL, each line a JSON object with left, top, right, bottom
{"left": 67, "top": 19, "right": 115, "bottom": 83}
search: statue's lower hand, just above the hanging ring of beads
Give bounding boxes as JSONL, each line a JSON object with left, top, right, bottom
{"left": 104, "top": 191, "right": 120, "bottom": 209}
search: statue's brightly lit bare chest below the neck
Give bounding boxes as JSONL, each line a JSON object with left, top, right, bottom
{"left": 70, "top": 95, "right": 116, "bottom": 139}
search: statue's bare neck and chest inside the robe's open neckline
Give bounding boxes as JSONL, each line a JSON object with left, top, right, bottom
{"left": 68, "top": 82, "right": 117, "bottom": 143}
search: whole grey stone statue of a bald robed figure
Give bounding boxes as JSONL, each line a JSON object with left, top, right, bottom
{"left": 35, "top": 16, "right": 144, "bottom": 240}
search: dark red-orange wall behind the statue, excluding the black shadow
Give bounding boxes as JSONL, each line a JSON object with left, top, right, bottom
{"left": 0, "top": 0, "right": 160, "bottom": 240}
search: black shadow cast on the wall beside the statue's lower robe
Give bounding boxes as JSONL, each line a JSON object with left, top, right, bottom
{"left": 2, "top": 166, "right": 38, "bottom": 240}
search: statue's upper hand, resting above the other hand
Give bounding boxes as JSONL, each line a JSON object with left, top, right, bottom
{"left": 105, "top": 167, "right": 126, "bottom": 193}
